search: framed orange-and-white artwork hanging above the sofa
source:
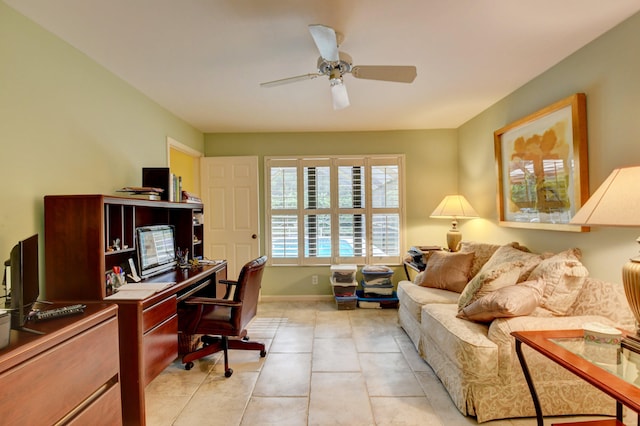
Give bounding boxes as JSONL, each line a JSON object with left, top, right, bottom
{"left": 494, "top": 93, "right": 589, "bottom": 232}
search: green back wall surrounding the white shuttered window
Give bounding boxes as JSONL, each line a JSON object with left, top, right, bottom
{"left": 205, "top": 130, "right": 464, "bottom": 296}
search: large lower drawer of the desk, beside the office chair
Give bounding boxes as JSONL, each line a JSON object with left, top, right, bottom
{"left": 142, "top": 311, "right": 178, "bottom": 386}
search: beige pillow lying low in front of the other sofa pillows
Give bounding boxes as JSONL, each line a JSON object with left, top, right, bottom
{"left": 458, "top": 279, "right": 545, "bottom": 322}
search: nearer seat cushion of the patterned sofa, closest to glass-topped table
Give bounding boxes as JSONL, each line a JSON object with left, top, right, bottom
{"left": 422, "top": 303, "right": 498, "bottom": 381}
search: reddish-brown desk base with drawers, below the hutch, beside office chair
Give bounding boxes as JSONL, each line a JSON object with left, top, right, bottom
{"left": 113, "top": 262, "right": 227, "bottom": 425}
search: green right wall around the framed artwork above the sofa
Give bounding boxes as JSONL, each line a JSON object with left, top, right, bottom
{"left": 458, "top": 14, "right": 640, "bottom": 282}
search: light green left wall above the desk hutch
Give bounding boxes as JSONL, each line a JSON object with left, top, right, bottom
{"left": 0, "top": 2, "right": 204, "bottom": 285}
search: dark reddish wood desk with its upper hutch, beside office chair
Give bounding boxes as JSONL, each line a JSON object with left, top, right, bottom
{"left": 44, "top": 195, "right": 226, "bottom": 425}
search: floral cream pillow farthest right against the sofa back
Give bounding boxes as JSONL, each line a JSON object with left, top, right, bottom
{"left": 530, "top": 249, "right": 589, "bottom": 315}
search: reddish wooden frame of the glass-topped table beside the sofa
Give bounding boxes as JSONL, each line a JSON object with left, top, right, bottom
{"left": 511, "top": 330, "right": 640, "bottom": 426}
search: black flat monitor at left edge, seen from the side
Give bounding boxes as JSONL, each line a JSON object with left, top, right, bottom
{"left": 9, "top": 234, "right": 40, "bottom": 331}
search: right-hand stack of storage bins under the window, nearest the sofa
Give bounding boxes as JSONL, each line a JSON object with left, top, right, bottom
{"left": 357, "top": 266, "right": 398, "bottom": 308}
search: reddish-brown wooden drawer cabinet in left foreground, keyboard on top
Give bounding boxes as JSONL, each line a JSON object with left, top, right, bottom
{"left": 0, "top": 303, "right": 122, "bottom": 425}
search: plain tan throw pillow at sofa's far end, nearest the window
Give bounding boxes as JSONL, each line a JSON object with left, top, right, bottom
{"left": 416, "top": 251, "right": 473, "bottom": 293}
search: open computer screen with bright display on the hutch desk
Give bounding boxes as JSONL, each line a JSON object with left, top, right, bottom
{"left": 136, "top": 225, "right": 178, "bottom": 278}
